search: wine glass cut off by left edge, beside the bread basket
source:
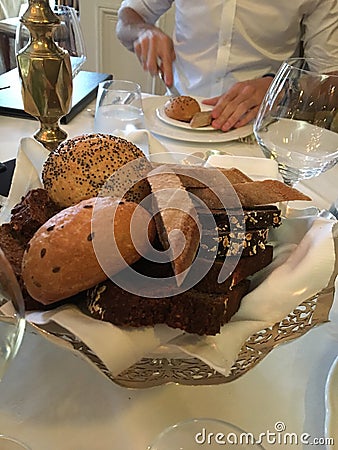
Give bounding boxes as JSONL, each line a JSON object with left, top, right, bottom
{"left": 0, "top": 248, "right": 29, "bottom": 450}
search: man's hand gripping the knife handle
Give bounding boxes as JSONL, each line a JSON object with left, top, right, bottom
{"left": 134, "top": 27, "right": 176, "bottom": 87}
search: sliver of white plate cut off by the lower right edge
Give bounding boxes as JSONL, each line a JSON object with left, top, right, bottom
{"left": 325, "top": 357, "right": 338, "bottom": 449}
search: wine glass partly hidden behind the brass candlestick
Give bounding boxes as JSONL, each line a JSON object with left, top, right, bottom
{"left": 15, "top": 5, "right": 87, "bottom": 78}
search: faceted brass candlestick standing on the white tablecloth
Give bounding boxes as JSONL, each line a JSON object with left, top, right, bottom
{"left": 17, "top": 0, "right": 73, "bottom": 151}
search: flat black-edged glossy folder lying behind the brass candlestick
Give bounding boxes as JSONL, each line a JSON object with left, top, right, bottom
{"left": 0, "top": 69, "right": 113, "bottom": 124}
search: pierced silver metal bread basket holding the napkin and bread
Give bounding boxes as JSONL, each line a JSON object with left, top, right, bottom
{"left": 33, "top": 284, "right": 337, "bottom": 389}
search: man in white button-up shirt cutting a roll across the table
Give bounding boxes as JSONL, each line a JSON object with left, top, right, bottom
{"left": 116, "top": 0, "right": 338, "bottom": 131}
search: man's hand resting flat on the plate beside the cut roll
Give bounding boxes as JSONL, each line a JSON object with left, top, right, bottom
{"left": 203, "top": 77, "right": 273, "bottom": 131}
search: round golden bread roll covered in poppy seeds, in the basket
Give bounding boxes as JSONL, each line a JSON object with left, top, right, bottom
{"left": 42, "top": 133, "right": 150, "bottom": 208}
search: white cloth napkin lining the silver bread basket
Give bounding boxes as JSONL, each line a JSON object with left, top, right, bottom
{"left": 0, "top": 135, "right": 338, "bottom": 375}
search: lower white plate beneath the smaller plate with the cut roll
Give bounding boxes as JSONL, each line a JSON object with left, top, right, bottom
{"left": 142, "top": 96, "right": 252, "bottom": 143}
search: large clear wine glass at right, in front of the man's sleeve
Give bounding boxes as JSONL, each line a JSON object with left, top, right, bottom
{"left": 254, "top": 58, "right": 338, "bottom": 186}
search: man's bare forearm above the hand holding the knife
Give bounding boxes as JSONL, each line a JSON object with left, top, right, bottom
{"left": 116, "top": 7, "right": 154, "bottom": 51}
